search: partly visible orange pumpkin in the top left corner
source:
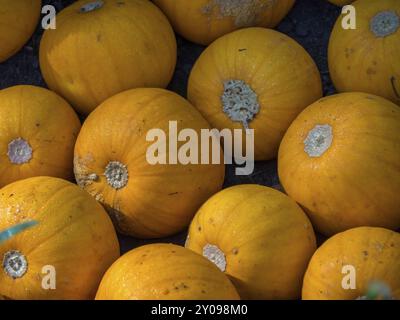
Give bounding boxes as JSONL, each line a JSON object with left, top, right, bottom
{"left": 0, "top": 0, "right": 42, "bottom": 63}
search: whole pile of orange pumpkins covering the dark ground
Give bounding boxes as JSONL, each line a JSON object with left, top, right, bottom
{"left": 0, "top": 0, "right": 400, "bottom": 299}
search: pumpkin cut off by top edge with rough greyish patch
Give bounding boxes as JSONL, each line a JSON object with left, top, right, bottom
{"left": 154, "top": 0, "right": 295, "bottom": 45}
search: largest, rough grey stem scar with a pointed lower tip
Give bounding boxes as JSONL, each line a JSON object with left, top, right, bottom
{"left": 221, "top": 80, "right": 260, "bottom": 129}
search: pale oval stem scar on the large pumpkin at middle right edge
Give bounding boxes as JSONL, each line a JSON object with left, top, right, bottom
{"left": 304, "top": 125, "right": 333, "bottom": 158}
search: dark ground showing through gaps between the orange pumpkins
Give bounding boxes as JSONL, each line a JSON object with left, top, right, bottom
{"left": 0, "top": 0, "right": 340, "bottom": 252}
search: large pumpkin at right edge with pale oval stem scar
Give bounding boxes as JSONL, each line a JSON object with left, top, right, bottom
{"left": 278, "top": 93, "right": 400, "bottom": 235}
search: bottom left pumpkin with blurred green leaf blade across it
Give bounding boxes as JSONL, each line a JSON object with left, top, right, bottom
{"left": 0, "top": 177, "right": 119, "bottom": 300}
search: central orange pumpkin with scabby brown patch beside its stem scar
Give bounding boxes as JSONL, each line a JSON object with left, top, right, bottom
{"left": 74, "top": 88, "right": 225, "bottom": 238}
